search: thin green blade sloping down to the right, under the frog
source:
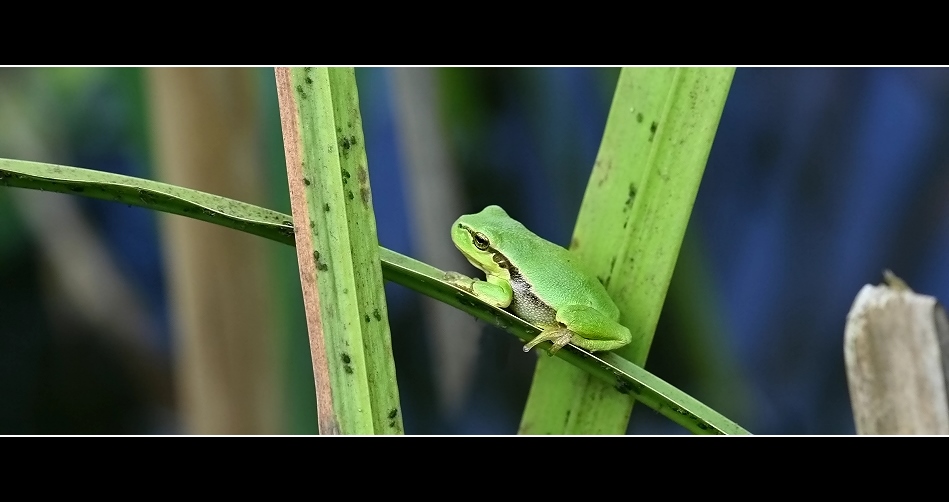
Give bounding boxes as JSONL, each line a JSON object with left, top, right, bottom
{"left": 0, "top": 159, "right": 749, "bottom": 434}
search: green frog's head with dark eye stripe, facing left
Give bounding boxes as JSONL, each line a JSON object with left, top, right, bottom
{"left": 451, "top": 206, "right": 522, "bottom": 279}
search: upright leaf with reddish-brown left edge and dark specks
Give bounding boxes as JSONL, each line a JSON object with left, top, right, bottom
{"left": 276, "top": 67, "right": 403, "bottom": 434}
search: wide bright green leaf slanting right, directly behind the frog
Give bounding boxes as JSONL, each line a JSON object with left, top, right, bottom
{"left": 520, "top": 68, "right": 734, "bottom": 434}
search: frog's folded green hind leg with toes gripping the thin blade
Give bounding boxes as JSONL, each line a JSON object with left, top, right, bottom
{"left": 524, "top": 305, "right": 633, "bottom": 355}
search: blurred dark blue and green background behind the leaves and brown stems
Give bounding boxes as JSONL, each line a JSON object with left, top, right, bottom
{"left": 0, "top": 68, "right": 949, "bottom": 434}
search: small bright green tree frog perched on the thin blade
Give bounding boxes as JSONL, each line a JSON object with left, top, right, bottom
{"left": 448, "top": 206, "right": 632, "bottom": 354}
